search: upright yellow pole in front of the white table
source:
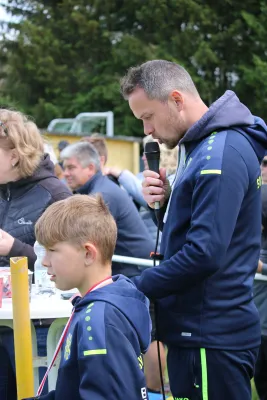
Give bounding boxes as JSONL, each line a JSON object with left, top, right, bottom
{"left": 10, "top": 257, "right": 34, "bottom": 400}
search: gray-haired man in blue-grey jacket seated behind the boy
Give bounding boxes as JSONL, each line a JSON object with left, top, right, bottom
{"left": 61, "top": 142, "right": 154, "bottom": 278}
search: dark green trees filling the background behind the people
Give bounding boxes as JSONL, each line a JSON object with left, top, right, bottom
{"left": 0, "top": 0, "right": 267, "bottom": 136}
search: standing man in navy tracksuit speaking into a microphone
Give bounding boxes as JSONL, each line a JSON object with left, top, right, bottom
{"left": 121, "top": 60, "right": 267, "bottom": 400}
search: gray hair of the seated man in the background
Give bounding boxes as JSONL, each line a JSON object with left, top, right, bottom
{"left": 60, "top": 142, "right": 100, "bottom": 171}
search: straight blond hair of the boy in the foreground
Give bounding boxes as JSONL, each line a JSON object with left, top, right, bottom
{"left": 35, "top": 194, "right": 117, "bottom": 264}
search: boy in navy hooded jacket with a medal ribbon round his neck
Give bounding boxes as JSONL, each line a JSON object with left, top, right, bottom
{"left": 24, "top": 195, "right": 150, "bottom": 400}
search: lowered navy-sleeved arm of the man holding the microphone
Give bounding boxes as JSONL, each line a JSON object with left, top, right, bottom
{"left": 136, "top": 147, "right": 253, "bottom": 299}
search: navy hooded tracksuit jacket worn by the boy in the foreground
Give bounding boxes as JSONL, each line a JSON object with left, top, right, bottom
{"left": 24, "top": 275, "right": 151, "bottom": 400}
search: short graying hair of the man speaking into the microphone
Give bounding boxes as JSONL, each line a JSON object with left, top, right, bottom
{"left": 121, "top": 60, "right": 199, "bottom": 101}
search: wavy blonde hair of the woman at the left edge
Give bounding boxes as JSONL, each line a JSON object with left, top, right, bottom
{"left": 0, "top": 109, "right": 44, "bottom": 178}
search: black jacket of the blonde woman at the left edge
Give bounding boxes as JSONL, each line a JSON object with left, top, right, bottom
{"left": 0, "top": 155, "right": 71, "bottom": 270}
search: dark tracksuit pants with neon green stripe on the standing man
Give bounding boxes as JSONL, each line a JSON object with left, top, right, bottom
{"left": 167, "top": 347, "right": 258, "bottom": 400}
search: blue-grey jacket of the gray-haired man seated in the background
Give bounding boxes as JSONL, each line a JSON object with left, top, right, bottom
{"left": 77, "top": 172, "right": 154, "bottom": 277}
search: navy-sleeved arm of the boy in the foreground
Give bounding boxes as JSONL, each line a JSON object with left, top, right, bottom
{"left": 77, "top": 302, "right": 148, "bottom": 400}
